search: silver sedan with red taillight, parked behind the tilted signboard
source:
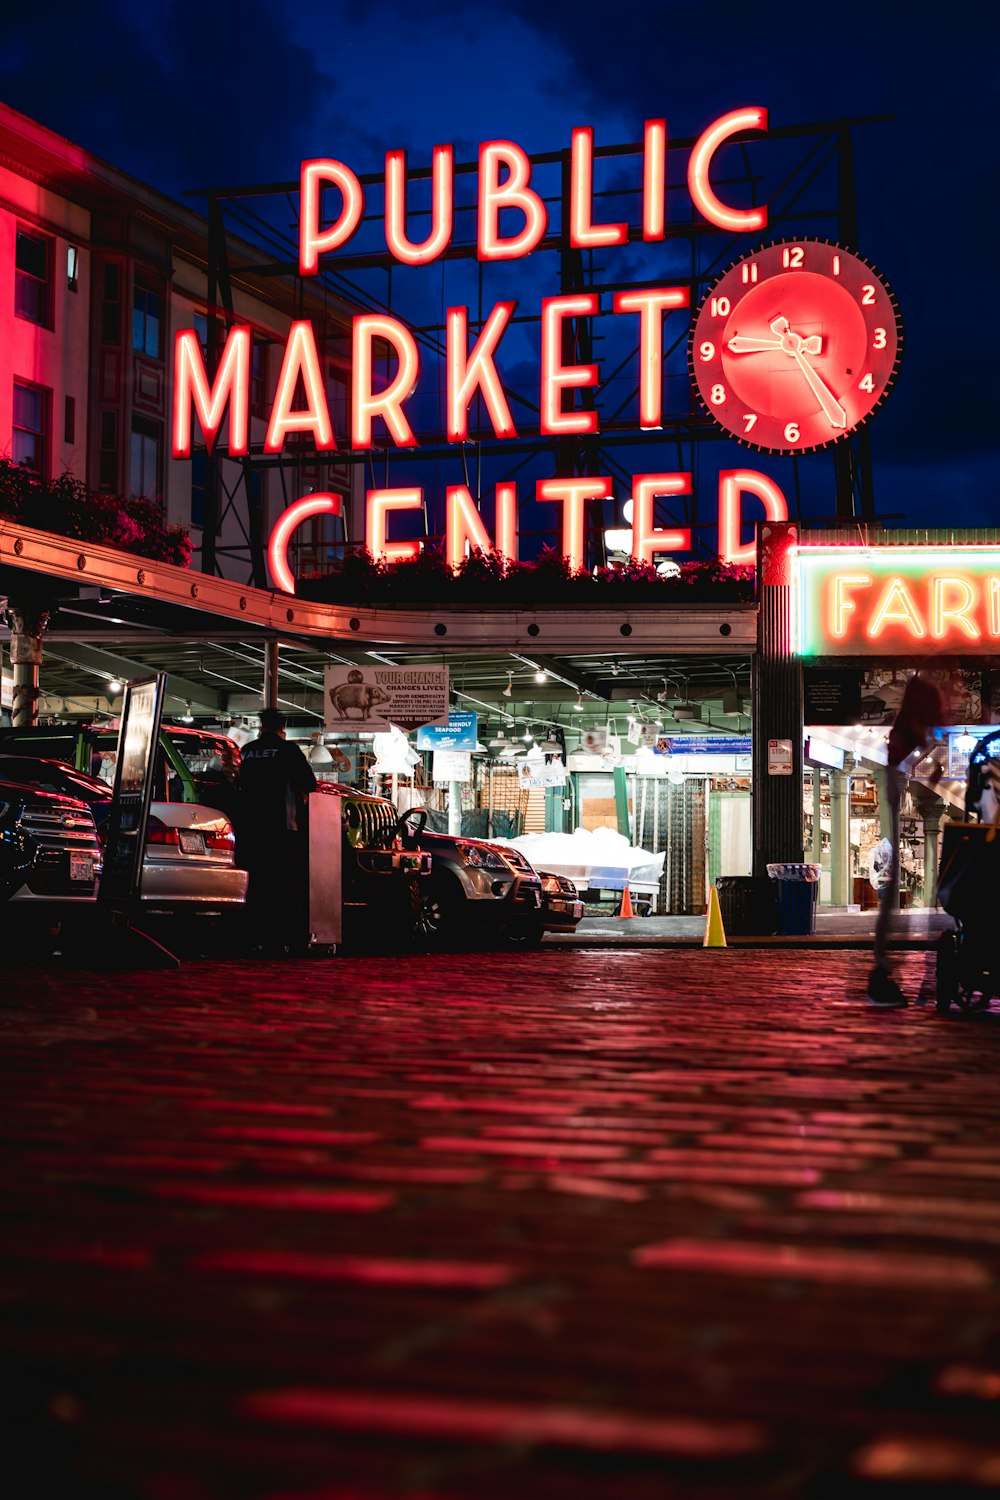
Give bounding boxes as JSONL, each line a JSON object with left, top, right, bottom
{"left": 0, "top": 755, "right": 247, "bottom": 923}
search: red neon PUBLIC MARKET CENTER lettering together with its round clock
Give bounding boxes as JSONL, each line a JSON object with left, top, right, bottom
{"left": 172, "top": 107, "right": 901, "bottom": 591}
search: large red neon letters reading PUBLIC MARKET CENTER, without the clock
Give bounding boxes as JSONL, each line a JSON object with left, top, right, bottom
{"left": 172, "top": 107, "right": 789, "bottom": 590}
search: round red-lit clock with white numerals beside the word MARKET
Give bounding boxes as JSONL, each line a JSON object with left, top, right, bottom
{"left": 688, "top": 240, "right": 903, "bottom": 453}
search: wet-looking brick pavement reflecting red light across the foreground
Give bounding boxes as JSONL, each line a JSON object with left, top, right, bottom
{"left": 0, "top": 950, "right": 1000, "bottom": 1500}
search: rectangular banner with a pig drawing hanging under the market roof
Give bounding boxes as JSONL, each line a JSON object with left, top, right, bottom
{"left": 322, "top": 665, "right": 448, "bottom": 734}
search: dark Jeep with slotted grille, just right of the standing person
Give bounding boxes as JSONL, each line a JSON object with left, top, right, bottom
{"left": 313, "top": 782, "right": 430, "bottom": 941}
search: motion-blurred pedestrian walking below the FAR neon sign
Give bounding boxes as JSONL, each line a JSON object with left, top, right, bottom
{"left": 868, "top": 672, "right": 945, "bottom": 1011}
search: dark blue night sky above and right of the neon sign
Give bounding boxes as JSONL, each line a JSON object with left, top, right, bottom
{"left": 0, "top": 0, "right": 1000, "bottom": 540}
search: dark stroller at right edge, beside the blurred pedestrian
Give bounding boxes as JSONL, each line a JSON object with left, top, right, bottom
{"left": 936, "top": 731, "right": 1000, "bottom": 1014}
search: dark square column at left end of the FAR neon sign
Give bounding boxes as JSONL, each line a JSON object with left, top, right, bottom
{"left": 753, "top": 521, "right": 802, "bottom": 876}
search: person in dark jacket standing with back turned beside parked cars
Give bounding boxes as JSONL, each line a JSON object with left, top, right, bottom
{"left": 237, "top": 708, "right": 316, "bottom": 957}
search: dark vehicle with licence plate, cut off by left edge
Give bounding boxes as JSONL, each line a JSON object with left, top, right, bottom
{"left": 0, "top": 780, "right": 100, "bottom": 950}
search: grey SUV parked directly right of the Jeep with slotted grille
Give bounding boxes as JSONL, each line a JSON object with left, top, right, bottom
{"left": 397, "top": 807, "right": 544, "bottom": 948}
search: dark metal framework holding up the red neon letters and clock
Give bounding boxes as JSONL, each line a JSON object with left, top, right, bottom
{"left": 192, "top": 117, "right": 885, "bottom": 587}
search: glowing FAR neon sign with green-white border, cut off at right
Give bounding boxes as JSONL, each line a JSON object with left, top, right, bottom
{"left": 796, "top": 548, "right": 1000, "bottom": 656}
